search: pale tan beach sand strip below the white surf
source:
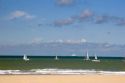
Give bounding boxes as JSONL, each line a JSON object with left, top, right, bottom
{"left": 0, "top": 75, "right": 125, "bottom": 83}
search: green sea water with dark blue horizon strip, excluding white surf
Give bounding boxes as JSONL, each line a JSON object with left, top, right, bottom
{"left": 0, "top": 56, "right": 125, "bottom": 71}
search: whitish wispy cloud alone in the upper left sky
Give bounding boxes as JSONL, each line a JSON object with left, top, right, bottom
{"left": 9, "top": 10, "right": 35, "bottom": 20}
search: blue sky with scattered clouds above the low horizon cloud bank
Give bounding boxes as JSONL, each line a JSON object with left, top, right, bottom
{"left": 0, "top": 0, "right": 125, "bottom": 45}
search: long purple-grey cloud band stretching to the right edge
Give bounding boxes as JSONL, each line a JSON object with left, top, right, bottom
{"left": 53, "top": 8, "right": 125, "bottom": 27}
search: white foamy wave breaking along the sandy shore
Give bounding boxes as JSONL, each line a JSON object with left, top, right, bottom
{"left": 0, "top": 69, "right": 125, "bottom": 75}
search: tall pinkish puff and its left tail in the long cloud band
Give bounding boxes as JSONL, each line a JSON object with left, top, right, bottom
{"left": 53, "top": 9, "right": 94, "bottom": 27}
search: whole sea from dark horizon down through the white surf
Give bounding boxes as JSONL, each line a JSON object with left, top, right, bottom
{"left": 0, "top": 55, "right": 125, "bottom": 75}
